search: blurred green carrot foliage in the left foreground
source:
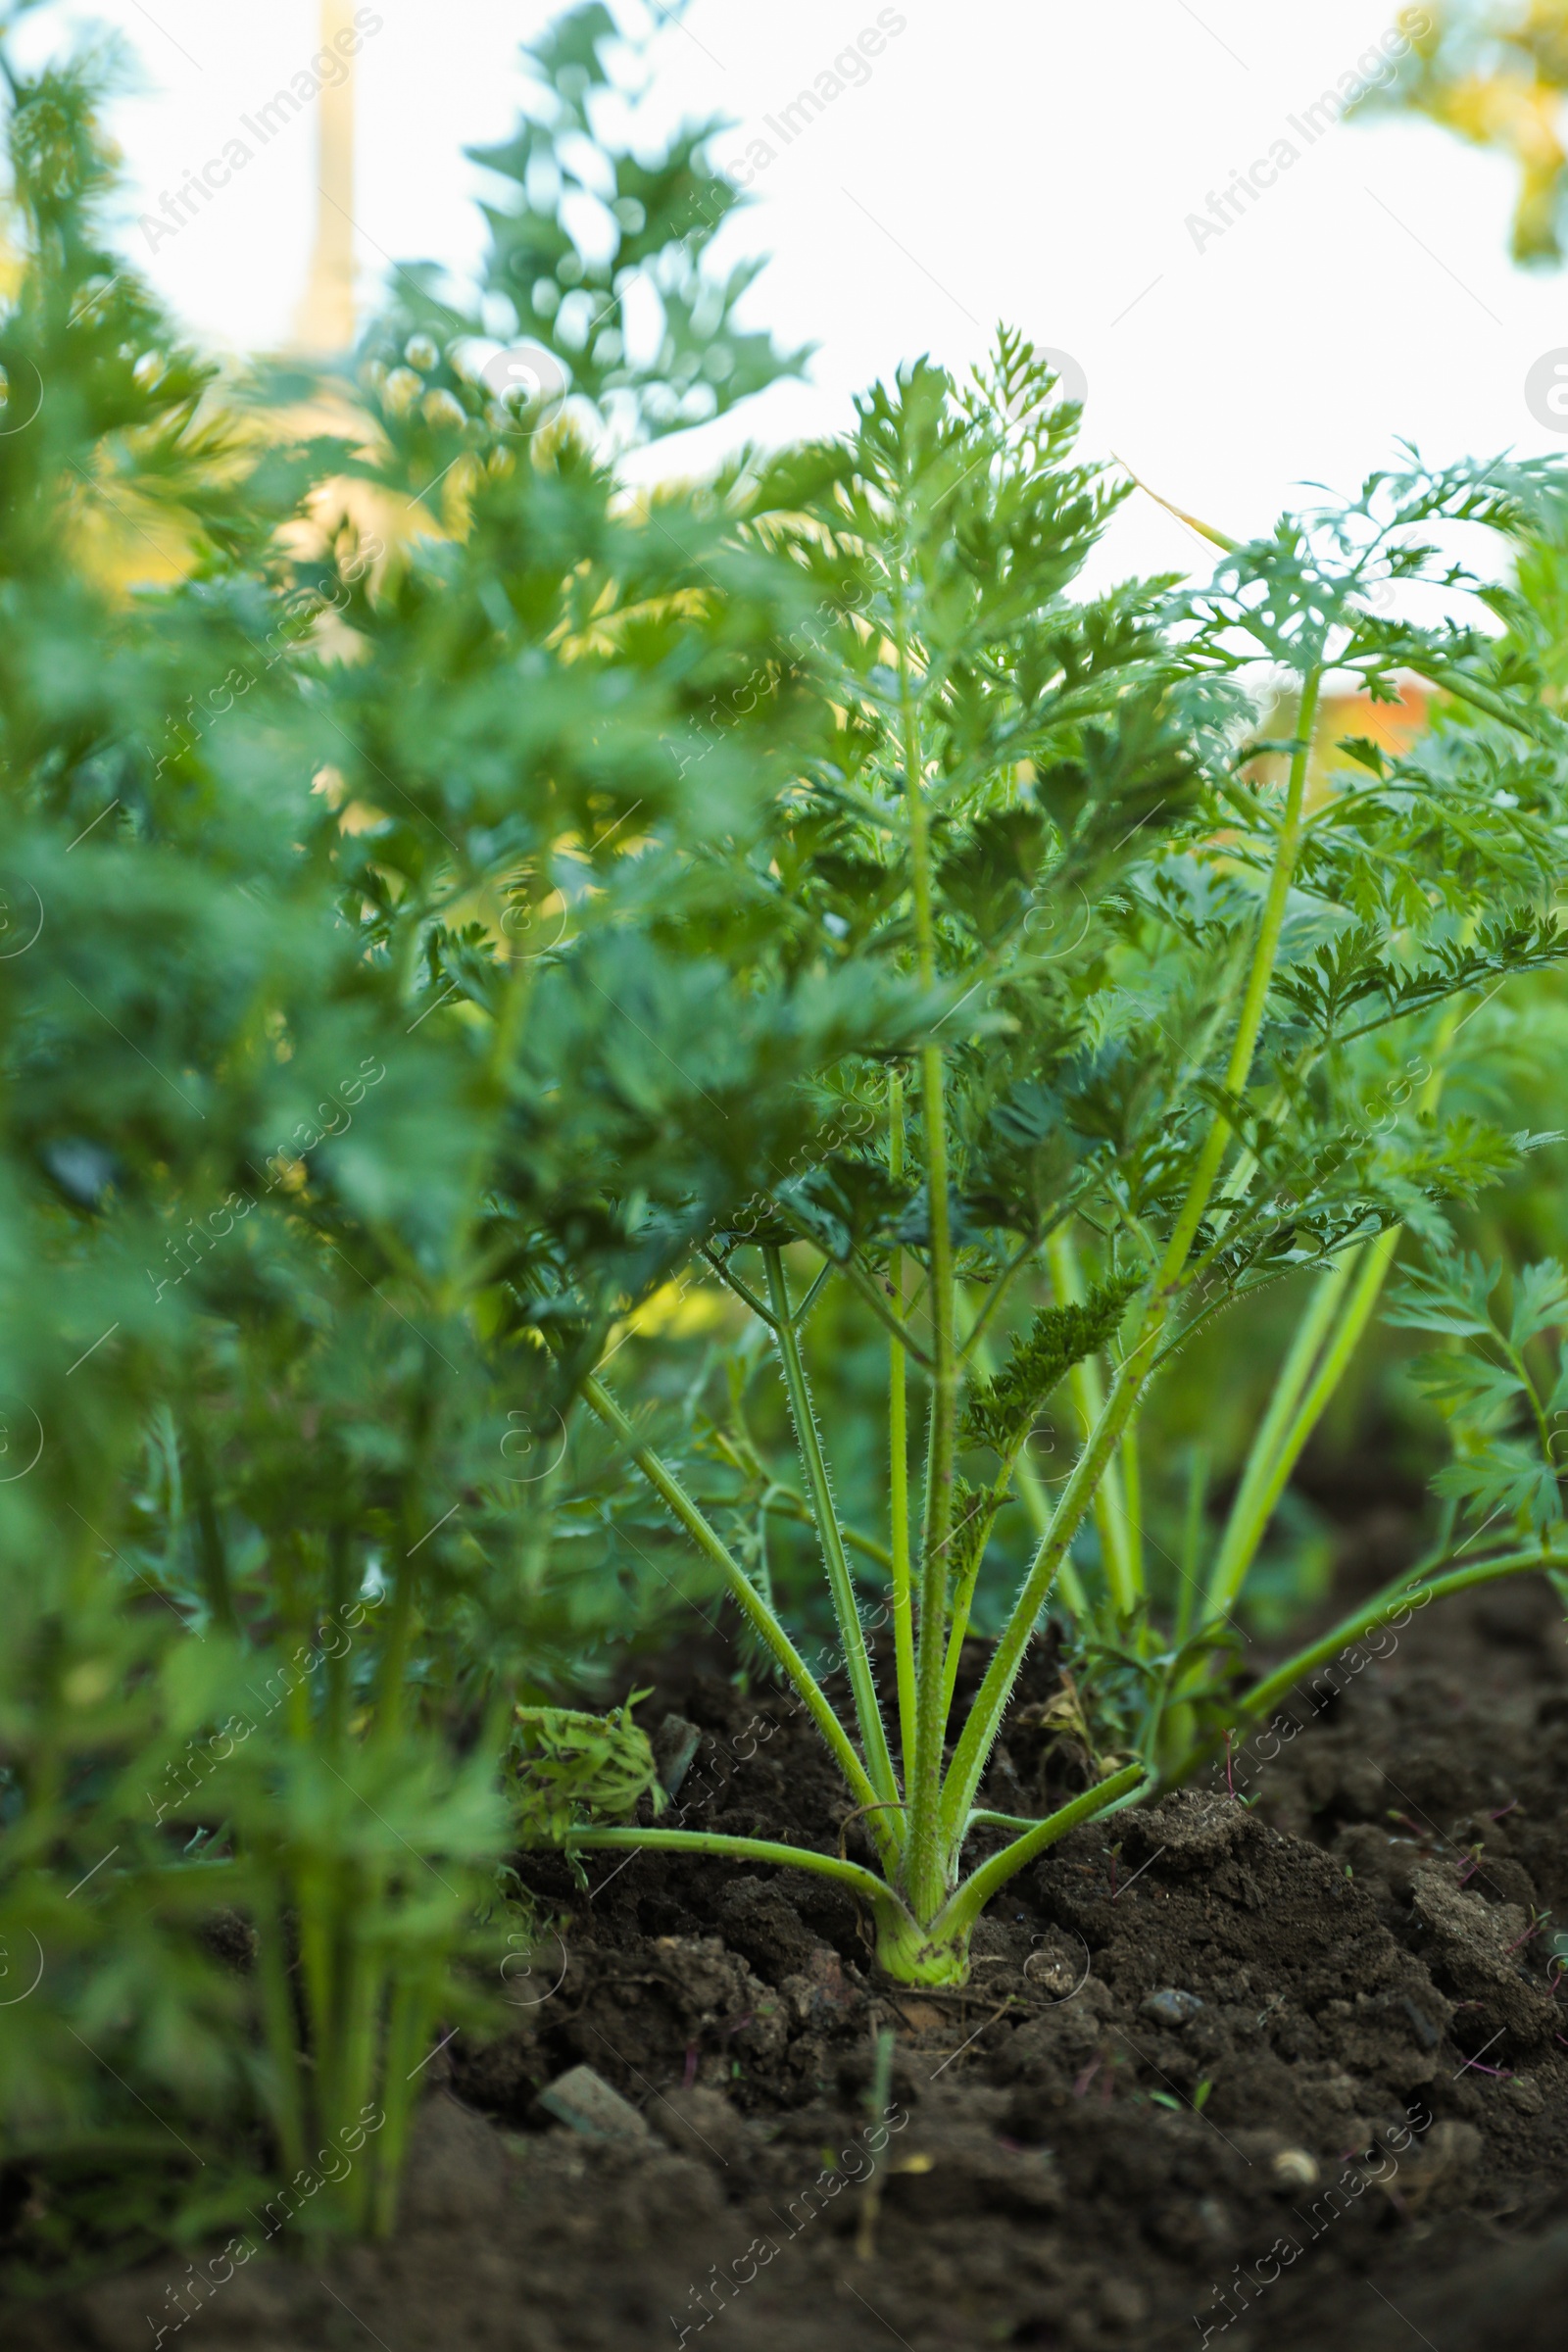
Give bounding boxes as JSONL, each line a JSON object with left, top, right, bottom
{"left": 0, "top": 7, "right": 919, "bottom": 2279}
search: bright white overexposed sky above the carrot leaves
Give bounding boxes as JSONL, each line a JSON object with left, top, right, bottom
{"left": 28, "top": 0, "right": 1568, "bottom": 571}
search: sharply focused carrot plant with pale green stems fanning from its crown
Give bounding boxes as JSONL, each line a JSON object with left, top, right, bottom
{"left": 576, "top": 348, "right": 1568, "bottom": 1983}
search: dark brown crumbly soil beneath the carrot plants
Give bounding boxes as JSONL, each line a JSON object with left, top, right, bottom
{"left": 10, "top": 1583, "right": 1568, "bottom": 2352}
